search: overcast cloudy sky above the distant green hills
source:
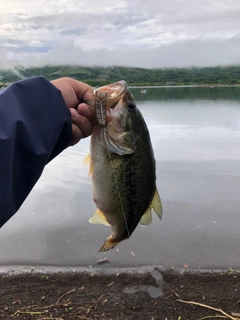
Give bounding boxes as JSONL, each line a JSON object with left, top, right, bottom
{"left": 0, "top": 0, "right": 240, "bottom": 68}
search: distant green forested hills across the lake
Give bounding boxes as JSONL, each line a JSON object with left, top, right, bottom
{"left": 0, "top": 65, "right": 240, "bottom": 87}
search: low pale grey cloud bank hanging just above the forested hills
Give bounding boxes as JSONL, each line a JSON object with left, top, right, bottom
{"left": 0, "top": 38, "right": 240, "bottom": 68}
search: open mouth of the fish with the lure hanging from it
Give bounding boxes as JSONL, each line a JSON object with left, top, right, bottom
{"left": 94, "top": 80, "right": 128, "bottom": 127}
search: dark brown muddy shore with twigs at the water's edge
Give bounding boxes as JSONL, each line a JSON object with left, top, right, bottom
{"left": 0, "top": 268, "right": 240, "bottom": 320}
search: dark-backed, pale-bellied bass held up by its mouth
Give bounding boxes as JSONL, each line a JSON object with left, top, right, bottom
{"left": 85, "top": 80, "right": 162, "bottom": 252}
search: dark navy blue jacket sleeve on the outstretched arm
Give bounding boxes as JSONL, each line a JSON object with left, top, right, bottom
{"left": 0, "top": 77, "right": 72, "bottom": 228}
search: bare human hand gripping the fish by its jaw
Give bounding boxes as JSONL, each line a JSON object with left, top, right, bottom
{"left": 51, "top": 78, "right": 96, "bottom": 146}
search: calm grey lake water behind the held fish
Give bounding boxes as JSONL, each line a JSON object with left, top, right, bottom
{"left": 0, "top": 87, "right": 240, "bottom": 268}
